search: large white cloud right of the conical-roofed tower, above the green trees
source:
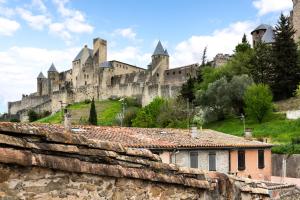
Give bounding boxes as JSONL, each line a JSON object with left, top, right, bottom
{"left": 170, "top": 21, "right": 255, "bottom": 67}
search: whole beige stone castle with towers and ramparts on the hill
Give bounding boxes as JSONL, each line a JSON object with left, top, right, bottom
{"left": 8, "top": 38, "right": 199, "bottom": 120}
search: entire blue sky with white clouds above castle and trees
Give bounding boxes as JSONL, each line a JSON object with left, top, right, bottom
{"left": 0, "top": 0, "right": 292, "bottom": 113}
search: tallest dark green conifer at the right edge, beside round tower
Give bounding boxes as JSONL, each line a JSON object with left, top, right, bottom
{"left": 271, "top": 14, "right": 300, "bottom": 100}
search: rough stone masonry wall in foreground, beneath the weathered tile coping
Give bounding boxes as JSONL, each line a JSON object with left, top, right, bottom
{"left": 0, "top": 164, "right": 207, "bottom": 200}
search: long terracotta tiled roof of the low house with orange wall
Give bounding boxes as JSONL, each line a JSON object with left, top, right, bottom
{"left": 0, "top": 123, "right": 272, "bottom": 149}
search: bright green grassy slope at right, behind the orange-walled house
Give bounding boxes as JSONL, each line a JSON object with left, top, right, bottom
{"left": 205, "top": 114, "right": 300, "bottom": 144}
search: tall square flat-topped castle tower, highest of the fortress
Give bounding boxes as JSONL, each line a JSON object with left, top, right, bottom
{"left": 93, "top": 38, "right": 107, "bottom": 65}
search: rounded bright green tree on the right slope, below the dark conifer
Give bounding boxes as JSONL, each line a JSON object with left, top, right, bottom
{"left": 244, "top": 84, "right": 273, "bottom": 123}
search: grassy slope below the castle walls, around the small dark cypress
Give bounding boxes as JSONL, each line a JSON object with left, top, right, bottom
{"left": 38, "top": 100, "right": 121, "bottom": 126}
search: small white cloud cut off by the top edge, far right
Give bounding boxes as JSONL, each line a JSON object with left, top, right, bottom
{"left": 253, "top": 0, "right": 293, "bottom": 16}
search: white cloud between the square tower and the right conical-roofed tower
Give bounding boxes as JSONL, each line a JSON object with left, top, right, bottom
{"left": 108, "top": 46, "right": 151, "bottom": 67}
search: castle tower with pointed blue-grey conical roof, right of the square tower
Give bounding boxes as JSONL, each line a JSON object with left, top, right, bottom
{"left": 150, "top": 41, "right": 169, "bottom": 82}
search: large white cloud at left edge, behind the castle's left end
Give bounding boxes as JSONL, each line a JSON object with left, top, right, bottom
{"left": 0, "top": 46, "right": 80, "bottom": 112}
